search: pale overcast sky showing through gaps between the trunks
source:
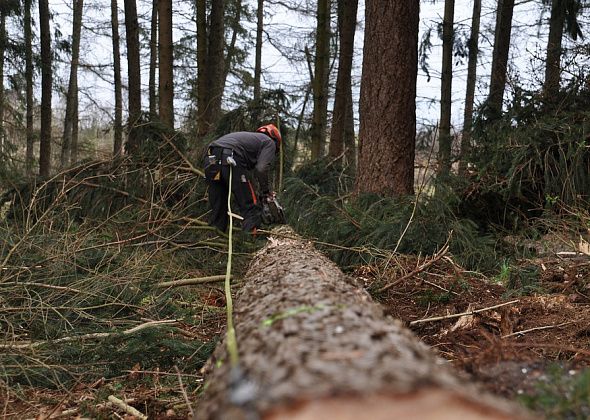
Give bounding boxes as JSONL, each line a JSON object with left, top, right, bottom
{"left": 30, "top": 0, "right": 576, "bottom": 133}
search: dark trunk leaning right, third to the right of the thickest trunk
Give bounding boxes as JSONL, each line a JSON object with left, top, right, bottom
{"left": 488, "top": 0, "right": 514, "bottom": 119}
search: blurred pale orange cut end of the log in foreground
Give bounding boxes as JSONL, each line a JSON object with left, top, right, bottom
{"left": 263, "top": 389, "right": 525, "bottom": 420}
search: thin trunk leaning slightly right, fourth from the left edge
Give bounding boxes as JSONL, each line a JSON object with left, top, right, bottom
{"left": 61, "top": 0, "right": 84, "bottom": 168}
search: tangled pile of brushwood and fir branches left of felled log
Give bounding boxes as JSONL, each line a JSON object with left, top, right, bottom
{"left": 0, "top": 121, "right": 260, "bottom": 415}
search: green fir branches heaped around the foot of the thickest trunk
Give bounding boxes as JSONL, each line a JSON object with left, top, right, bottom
{"left": 282, "top": 159, "right": 513, "bottom": 272}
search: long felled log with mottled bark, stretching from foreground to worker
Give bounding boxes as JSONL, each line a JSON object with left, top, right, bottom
{"left": 196, "top": 228, "right": 525, "bottom": 420}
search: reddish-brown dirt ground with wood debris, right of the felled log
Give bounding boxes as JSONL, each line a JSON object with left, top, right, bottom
{"left": 354, "top": 251, "right": 590, "bottom": 406}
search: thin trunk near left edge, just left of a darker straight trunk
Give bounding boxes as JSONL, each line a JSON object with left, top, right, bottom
{"left": 24, "top": 0, "right": 35, "bottom": 176}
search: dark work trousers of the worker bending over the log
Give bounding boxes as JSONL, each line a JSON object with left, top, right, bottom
{"left": 205, "top": 164, "right": 262, "bottom": 232}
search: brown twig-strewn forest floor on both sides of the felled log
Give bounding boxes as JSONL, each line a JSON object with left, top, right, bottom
{"left": 0, "top": 238, "right": 590, "bottom": 419}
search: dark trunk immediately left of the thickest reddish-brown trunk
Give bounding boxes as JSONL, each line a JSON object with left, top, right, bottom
{"left": 328, "top": 0, "right": 358, "bottom": 171}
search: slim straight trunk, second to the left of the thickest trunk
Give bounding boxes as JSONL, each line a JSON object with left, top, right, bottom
{"left": 311, "top": 0, "right": 330, "bottom": 160}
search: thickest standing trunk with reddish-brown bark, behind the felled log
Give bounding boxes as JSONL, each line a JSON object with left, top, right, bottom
{"left": 356, "top": 0, "right": 420, "bottom": 196}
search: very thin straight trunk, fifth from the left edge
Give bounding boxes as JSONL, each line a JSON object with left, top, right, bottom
{"left": 111, "top": 0, "right": 123, "bottom": 158}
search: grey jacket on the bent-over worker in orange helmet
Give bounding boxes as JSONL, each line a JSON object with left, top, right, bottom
{"left": 209, "top": 131, "right": 276, "bottom": 193}
